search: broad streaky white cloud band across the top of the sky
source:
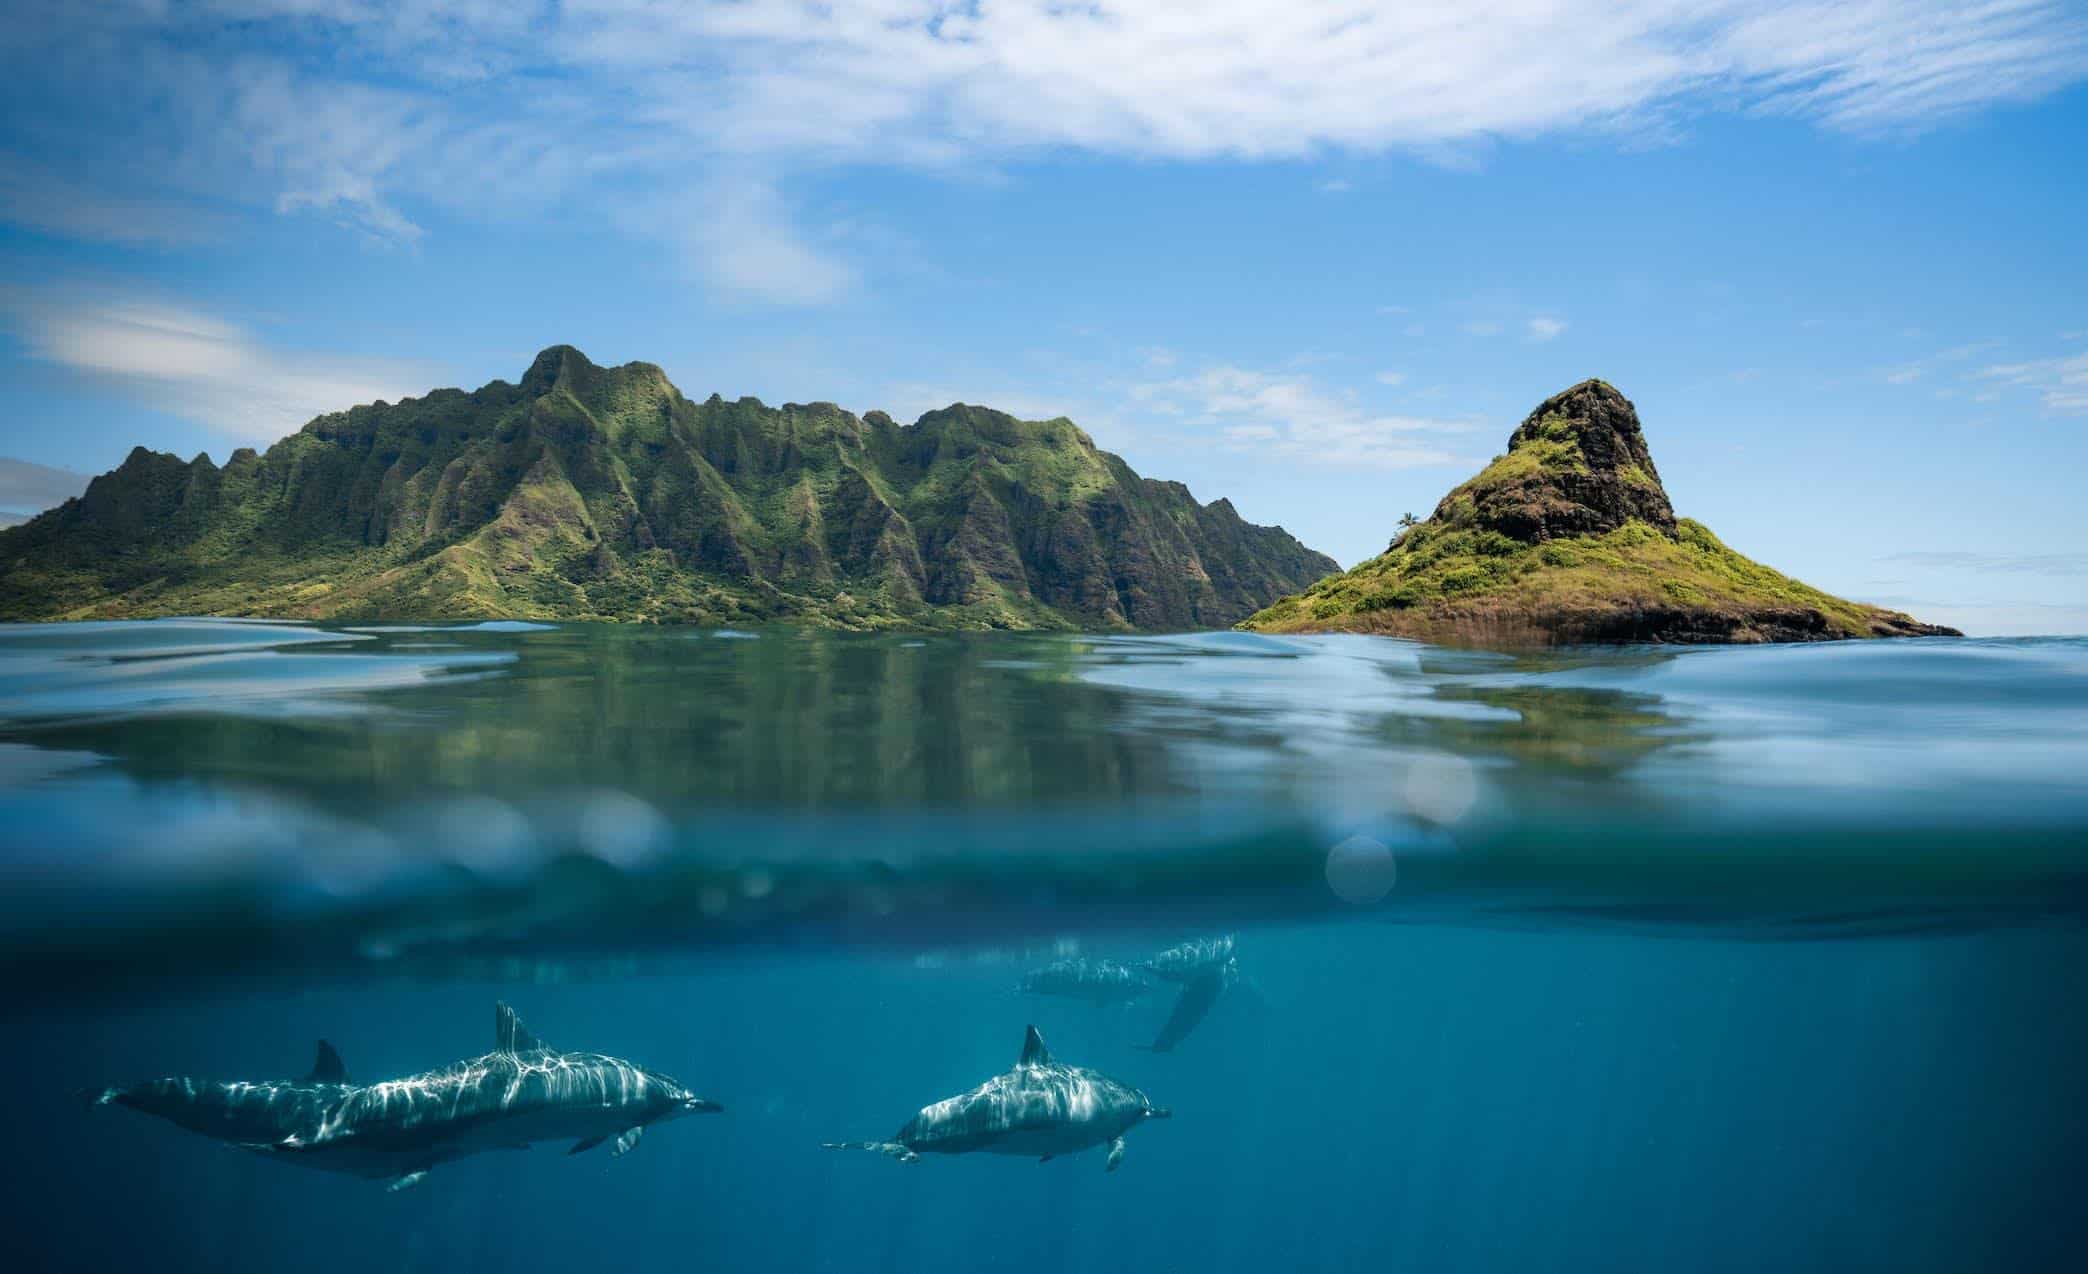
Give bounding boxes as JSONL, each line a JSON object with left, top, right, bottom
{"left": 0, "top": 0, "right": 2088, "bottom": 303}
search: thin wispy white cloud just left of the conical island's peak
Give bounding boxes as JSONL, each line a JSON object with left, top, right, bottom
{"left": 1132, "top": 363, "right": 1476, "bottom": 468}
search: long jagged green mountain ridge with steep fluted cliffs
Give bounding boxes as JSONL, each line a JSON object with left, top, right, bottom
{"left": 0, "top": 347, "right": 1336, "bottom": 629}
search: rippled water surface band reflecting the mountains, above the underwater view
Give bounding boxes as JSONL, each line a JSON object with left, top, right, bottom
{"left": 0, "top": 620, "right": 2088, "bottom": 982}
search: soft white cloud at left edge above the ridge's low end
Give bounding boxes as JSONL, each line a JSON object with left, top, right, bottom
{"left": 8, "top": 299, "right": 444, "bottom": 443}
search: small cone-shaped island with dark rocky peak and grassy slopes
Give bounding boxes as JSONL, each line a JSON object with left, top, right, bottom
{"left": 1240, "top": 371, "right": 1959, "bottom": 645}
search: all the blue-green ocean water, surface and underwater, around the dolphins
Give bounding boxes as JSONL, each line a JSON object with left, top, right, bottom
{"left": 0, "top": 620, "right": 2088, "bottom": 1274}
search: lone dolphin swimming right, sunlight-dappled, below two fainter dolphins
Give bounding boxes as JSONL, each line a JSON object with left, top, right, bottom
{"left": 823, "top": 1025, "right": 1173, "bottom": 1172}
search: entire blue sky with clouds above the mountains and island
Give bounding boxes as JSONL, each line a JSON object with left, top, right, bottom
{"left": 0, "top": 0, "right": 2088, "bottom": 633}
